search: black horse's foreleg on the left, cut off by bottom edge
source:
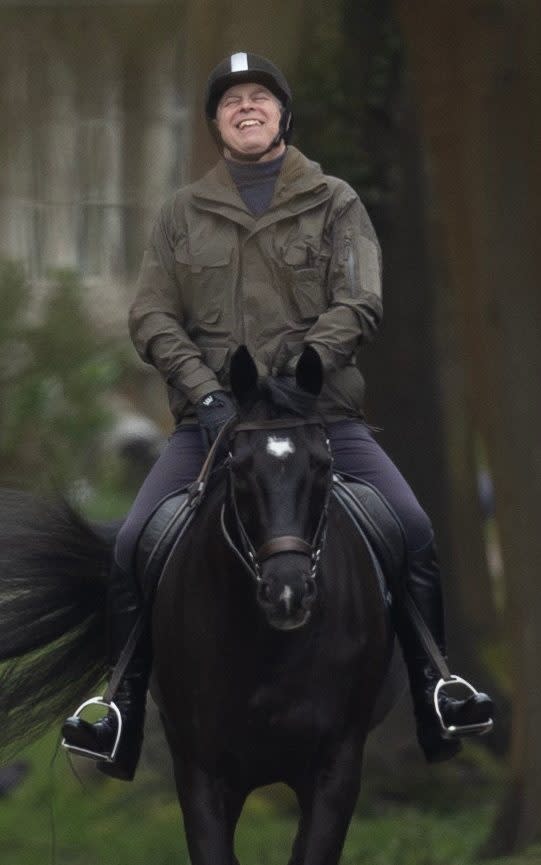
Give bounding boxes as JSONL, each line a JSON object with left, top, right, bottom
{"left": 175, "top": 764, "right": 246, "bottom": 865}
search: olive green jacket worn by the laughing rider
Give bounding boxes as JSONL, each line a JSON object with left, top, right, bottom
{"left": 129, "top": 147, "right": 382, "bottom": 422}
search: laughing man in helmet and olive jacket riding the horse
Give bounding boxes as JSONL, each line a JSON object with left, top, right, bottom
{"left": 63, "top": 52, "right": 493, "bottom": 780}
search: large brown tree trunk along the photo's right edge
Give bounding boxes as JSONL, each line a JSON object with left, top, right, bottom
{"left": 397, "top": 0, "right": 541, "bottom": 855}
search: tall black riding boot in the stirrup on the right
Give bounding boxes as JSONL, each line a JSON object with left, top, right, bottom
{"left": 394, "top": 543, "right": 494, "bottom": 763}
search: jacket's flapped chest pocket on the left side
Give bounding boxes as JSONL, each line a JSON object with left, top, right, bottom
{"left": 175, "top": 240, "right": 231, "bottom": 324}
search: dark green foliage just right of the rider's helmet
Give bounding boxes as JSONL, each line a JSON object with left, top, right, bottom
{"left": 292, "top": 0, "right": 402, "bottom": 204}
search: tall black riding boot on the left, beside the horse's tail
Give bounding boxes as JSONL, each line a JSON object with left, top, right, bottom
{"left": 62, "top": 564, "right": 152, "bottom": 781}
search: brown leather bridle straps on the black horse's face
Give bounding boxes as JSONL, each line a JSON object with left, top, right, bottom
{"left": 220, "top": 418, "right": 332, "bottom": 583}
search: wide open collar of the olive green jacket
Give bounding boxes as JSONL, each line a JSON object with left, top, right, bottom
{"left": 192, "top": 146, "right": 331, "bottom": 233}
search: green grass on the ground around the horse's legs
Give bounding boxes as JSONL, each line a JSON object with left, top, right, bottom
{"left": 0, "top": 737, "right": 541, "bottom": 865}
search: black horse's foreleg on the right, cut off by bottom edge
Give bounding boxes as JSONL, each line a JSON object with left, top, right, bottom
{"left": 289, "top": 733, "right": 363, "bottom": 865}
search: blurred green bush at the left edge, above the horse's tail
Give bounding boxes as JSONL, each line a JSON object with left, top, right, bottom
{"left": 0, "top": 261, "right": 125, "bottom": 488}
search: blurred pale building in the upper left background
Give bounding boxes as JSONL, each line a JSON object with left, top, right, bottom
{"left": 0, "top": 0, "right": 189, "bottom": 323}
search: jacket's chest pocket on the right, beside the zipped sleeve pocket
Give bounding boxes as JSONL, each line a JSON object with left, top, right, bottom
{"left": 282, "top": 243, "right": 328, "bottom": 321}
